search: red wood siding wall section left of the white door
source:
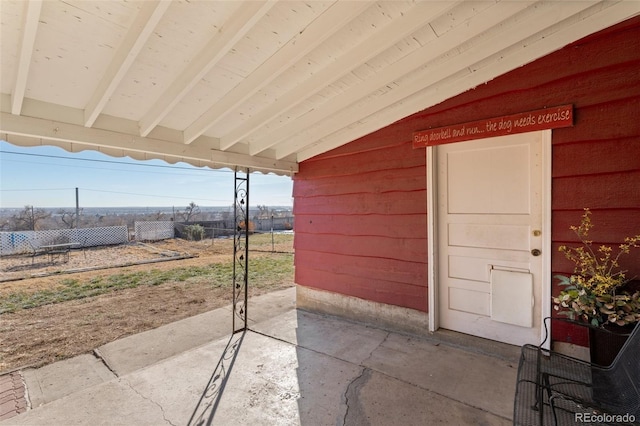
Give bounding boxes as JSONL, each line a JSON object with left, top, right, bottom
{"left": 293, "top": 127, "right": 427, "bottom": 311}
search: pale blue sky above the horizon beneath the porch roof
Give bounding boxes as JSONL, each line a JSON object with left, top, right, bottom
{"left": 0, "top": 141, "right": 293, "bottom": 208}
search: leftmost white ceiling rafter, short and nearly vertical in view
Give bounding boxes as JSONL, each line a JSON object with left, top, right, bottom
{"left": 11, "top": 0, "right": 42, "bottom": 115}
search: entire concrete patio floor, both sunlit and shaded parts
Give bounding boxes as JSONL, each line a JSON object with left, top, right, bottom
{"left": 0, "top": 289, "right": 518, "bottom": 425}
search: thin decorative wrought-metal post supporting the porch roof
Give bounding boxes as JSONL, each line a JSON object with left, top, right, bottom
{"left": 232, "top": 169, "right": 249, "bottom": 333}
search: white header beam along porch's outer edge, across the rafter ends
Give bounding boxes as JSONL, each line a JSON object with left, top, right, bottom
{"left": 0, "top": 112, "right": 298, "bottom": 174}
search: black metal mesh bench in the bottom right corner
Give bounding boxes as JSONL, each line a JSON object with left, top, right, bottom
{"left": 513, "top": 318, "right": 640, "bottom": 426}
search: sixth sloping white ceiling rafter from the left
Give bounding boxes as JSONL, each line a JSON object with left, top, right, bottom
{"left": 252, "top": 2, "right": 533, "bottom": 156}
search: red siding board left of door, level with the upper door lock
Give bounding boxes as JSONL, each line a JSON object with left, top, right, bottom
{"left": 296, "top": 213, "right": 427, "bottom": 239}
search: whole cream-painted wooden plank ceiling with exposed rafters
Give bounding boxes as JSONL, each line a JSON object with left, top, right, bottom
{"left": 0, "top": 0, "right": 640, "bottom": 174}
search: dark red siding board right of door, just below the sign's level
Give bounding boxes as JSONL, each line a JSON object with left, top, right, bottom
{"left": 552, "top": 137, "right": 640, "bottom": 178}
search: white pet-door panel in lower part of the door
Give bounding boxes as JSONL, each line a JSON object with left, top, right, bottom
{"left": 491, "top": 269, "right": 534, "bottom": 327}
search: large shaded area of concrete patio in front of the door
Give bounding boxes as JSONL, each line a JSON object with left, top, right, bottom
{"left": 288, "top": 310, "right": 515, "bottom": 426}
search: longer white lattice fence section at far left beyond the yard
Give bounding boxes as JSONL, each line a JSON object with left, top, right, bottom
{"left": 0, "top": 226, "right": 129, "bottom": 256}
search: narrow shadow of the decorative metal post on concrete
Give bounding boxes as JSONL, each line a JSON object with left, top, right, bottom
{"left": 187, "top": 331, "right": 246, "bottom": 426}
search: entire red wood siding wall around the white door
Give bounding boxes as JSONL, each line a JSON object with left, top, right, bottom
{"left": 294, "top": 18, "right": 640, "bottom": 311}
